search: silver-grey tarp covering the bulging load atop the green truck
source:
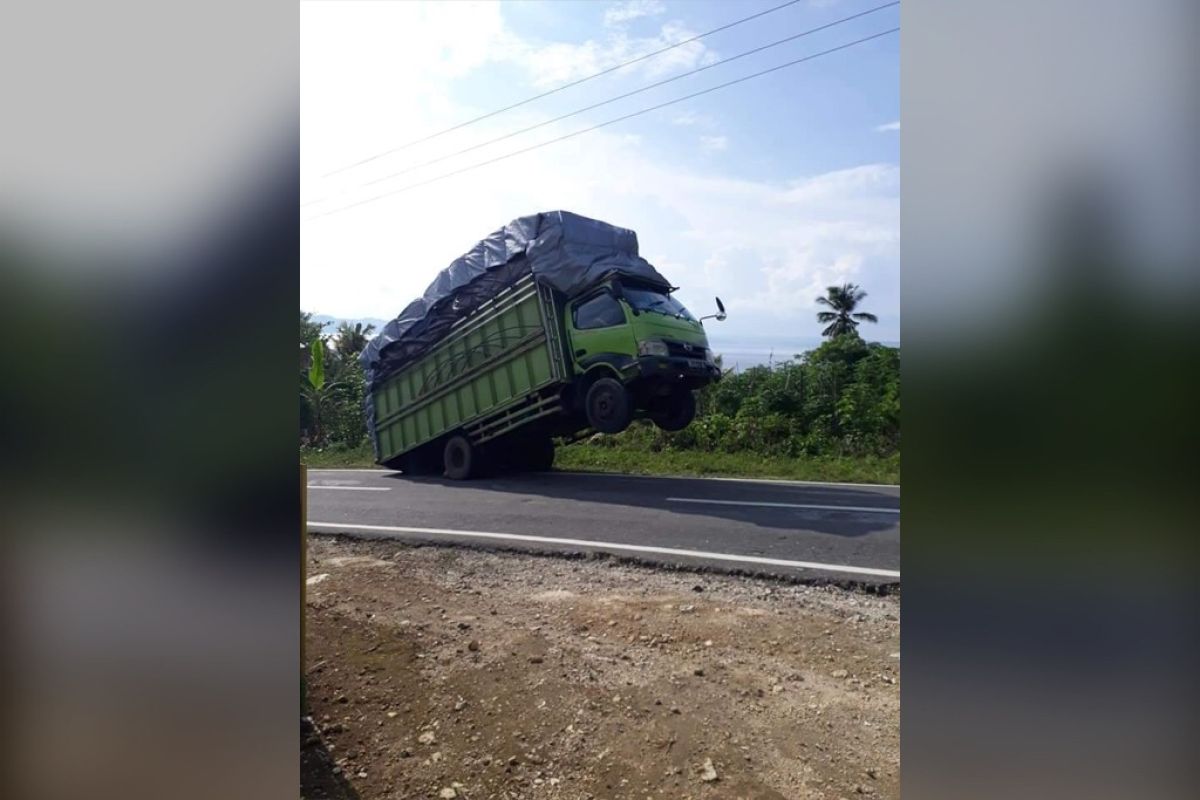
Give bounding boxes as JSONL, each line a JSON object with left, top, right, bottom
{"left": 359, "top": 211, "right": 670, "bottom": 388}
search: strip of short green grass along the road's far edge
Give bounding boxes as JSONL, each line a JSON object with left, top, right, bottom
{"left": 300, "top": 443, "right": 900, "bottom": 483}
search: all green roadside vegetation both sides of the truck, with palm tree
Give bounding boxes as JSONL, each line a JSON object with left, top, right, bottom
{"left": 300, "top": 284, "right": 900, "bottom": 483}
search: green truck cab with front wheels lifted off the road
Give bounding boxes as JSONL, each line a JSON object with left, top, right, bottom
{"left": 563, "top": 278, "right": 724, "bottom": 433}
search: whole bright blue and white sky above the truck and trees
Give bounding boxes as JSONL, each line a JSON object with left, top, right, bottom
{"left": 300, "top": 0, "right": 900, "bottom": 343}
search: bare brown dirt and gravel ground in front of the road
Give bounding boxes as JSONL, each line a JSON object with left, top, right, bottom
{"left": 301, "top": 536, "right": 900, "bottom": 800}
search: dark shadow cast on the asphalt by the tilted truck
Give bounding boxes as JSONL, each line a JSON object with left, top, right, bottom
{"left": 386, "top": 473, "right": 900, "bottom": 537}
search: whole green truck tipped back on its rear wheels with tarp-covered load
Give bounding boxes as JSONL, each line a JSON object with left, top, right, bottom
{"left": 360, "top": 211, "right": 725, "bottom": 480}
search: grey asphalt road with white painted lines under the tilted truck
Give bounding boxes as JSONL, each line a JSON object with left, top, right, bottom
{"left": 308, "top": 469, "right": 900, "bottom": 583}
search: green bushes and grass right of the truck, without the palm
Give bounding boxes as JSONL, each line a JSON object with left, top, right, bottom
{"left": 556, "top": 331, "right": 900, "bottom": 483}
